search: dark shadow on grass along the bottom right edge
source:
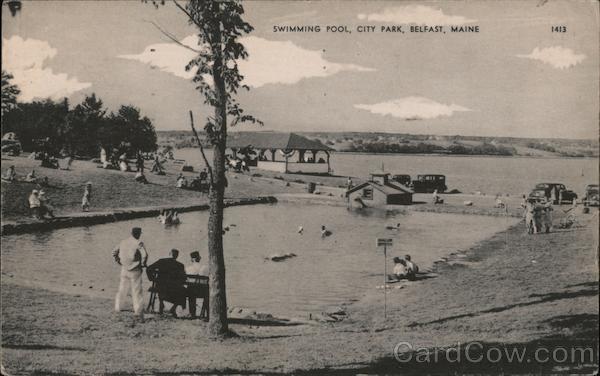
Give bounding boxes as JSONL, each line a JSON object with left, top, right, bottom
{"left": 97, "top": 314, "right": 598, "bottom": 376}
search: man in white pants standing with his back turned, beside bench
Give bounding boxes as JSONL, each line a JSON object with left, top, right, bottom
{"left": 113, "top": 227, "right": 148, "bottom": 318}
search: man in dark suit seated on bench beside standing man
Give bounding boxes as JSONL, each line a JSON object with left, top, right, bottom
{"left": 146, "top": 249, "right": 187, "bottom": 317}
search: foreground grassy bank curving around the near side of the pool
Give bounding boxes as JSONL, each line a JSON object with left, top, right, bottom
{"left": 2, "top": 207, "right": 598, "bottom": 375}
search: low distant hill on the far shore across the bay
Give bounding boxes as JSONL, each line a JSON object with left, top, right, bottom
{"left": 157, "top": 131, "right": 599, "bottom": 157}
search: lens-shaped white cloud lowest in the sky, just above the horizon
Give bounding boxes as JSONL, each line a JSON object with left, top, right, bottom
{"left": 354, "top": 97, "right": 472, "bottom": 120}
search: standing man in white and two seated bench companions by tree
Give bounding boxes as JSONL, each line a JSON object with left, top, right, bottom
{"left": 112, "top": 227, "right": 208, "bottom": 318}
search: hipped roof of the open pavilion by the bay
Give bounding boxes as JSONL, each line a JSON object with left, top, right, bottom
{"left": 227, "top": 131, "right": 333, "bottom": 151}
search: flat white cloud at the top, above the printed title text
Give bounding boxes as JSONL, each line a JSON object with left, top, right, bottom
{"left": 358, "top": 5, "right": 477, "bottom": 26}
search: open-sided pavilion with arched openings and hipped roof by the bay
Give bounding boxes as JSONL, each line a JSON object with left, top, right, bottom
{"left": 227, "top": 131, "right": 333, "bottom": 174}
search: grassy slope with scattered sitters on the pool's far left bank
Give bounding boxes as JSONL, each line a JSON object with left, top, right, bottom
{"left": 2, "top": 156, "right": 305, "bottom": 220}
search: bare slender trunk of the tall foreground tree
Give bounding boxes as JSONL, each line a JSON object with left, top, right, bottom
{"left": 208, "top": 27, "right": 229, "bottom": 336}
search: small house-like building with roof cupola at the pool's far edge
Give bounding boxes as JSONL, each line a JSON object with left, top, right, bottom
{"left": 346, "top": 172, "right": 413, "bottom": 206}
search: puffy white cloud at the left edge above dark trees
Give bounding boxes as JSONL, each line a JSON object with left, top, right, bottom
{"left": 2, "top": 35, "right": 92, "bottom": 102}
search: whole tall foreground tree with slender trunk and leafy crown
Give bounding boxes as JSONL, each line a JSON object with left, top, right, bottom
{"left": 152, "top": 0, "right": 260, "bottom": 336}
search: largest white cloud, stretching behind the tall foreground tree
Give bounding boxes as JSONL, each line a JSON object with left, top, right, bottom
{"left": 119, "top": 36, "right": 374, "bottom": 87}
